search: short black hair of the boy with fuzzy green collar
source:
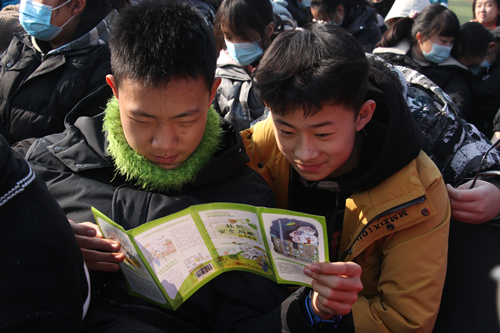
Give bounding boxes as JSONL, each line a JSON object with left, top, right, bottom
{"left": 109, "top": 0, "right": 217, "bottom": 90}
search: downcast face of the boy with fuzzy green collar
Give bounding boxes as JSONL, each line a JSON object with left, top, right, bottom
{"left": 117, "top": 79, "right": 213, "bottom": 169}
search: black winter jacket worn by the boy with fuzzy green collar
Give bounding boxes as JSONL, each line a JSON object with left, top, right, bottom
{"left": 20, "top": 105, "right": 328, "bottom": 332}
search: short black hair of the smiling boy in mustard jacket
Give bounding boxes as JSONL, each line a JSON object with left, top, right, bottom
{"left": 255, "top": 24, "right": 370, "bottom": 117}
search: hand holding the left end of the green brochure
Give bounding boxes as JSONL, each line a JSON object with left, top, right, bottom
{"left": 69, "top": 220, "right": 125, "bottom": 272}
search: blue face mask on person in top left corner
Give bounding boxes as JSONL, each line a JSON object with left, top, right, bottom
{"left": 19, "top": 0, "right": 74, "bottom": 41}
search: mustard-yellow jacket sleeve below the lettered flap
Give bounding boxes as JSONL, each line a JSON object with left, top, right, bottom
{"left": 352, "top": 159, "right": 451, "bottom": 333}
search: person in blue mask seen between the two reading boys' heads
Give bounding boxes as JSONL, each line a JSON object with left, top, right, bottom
{"left": 213, "top": 0, "right": 295, "bottom": 130}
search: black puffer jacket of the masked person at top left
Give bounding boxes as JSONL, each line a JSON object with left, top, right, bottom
{"left": 0, "top": 10, "right": 117, "bottom": 145}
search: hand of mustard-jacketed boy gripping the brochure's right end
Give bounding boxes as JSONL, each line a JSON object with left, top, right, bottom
{"left": 304, "top": 262, "right": 363, "bottom": 320}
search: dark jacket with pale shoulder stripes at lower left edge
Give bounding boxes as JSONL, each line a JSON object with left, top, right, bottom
{"left": 0, "top": 135, "right": 90, "bottom": 333}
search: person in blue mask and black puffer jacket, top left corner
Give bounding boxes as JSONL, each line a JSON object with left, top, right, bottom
{"left": 0, "top": 0, "right": 117, "bottom": 145}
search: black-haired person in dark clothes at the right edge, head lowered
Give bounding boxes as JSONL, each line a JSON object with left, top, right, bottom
{"left": 453, "top": 22, "right": 500, "bottom": 138}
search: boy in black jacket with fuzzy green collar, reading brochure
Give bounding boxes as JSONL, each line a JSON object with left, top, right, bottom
{"left": 20, "top": 0, "right": 361, "bottom": 332}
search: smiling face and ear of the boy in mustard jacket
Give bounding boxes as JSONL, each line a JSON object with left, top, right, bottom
{"left": 271, "top": 100, "right": 375, "bottom": 181}
